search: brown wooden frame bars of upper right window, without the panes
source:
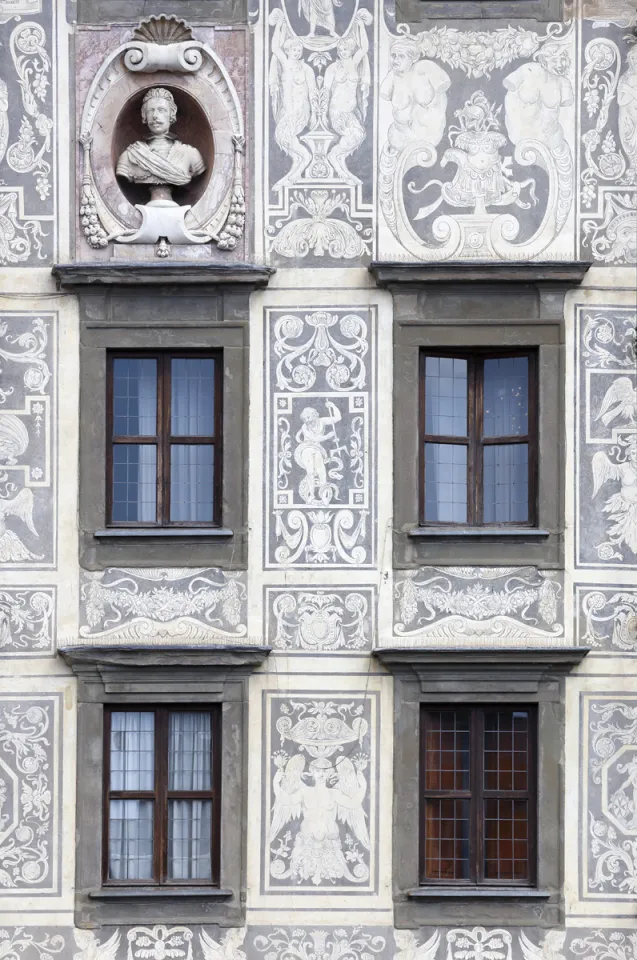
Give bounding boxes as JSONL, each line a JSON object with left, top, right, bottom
{"left": 418, "top": 347, "right": 539, "bottom": 528}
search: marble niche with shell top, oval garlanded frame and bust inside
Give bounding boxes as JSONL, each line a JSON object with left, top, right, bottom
{"left": 79, "top": 15, "right": 245, "bottom": 259}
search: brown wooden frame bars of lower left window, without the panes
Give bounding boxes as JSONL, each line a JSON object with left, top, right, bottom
{"left": 102, "top": 703, "right": 221, "bottom": 889}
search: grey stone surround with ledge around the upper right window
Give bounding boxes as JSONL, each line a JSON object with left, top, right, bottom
{"left": 370, "top": 262, "right": 589, "bottom": 569}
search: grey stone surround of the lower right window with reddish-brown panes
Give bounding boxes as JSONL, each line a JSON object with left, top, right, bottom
{"left": 375, "top": 647, "right": 588, "bottom": 929}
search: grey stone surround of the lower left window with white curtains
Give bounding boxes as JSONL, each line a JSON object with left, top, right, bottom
{"left": 60, "top": 646, "right": 270, "bottom": 929}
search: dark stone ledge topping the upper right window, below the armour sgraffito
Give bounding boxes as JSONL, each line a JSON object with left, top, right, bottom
{"left": 368, "top": 260, "right": 592, "bottom": 288}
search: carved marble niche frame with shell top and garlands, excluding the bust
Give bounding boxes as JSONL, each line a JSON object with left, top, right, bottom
{"left": 77, "top": 14, "right": 245, "bottom": 261}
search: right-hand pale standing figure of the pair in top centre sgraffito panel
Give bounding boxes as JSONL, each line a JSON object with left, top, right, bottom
{"left": 324, "top": 10, "right": 372, "bottom": 184}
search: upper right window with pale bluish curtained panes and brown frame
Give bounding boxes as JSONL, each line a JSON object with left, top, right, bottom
{"left": 420, "top": 350, "right": 537, "bottom": 527}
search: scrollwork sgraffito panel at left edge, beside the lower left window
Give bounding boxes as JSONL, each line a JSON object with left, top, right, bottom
{"left": 0, "top": 696, "right": 60, "bottom": 892}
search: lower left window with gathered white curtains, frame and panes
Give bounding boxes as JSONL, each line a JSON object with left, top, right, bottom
{"left": 104, "top": 707, "right": 221, "bottom": 885}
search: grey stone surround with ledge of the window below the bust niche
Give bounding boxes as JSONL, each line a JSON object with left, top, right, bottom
{"left": 53, "top": 262, "right": 273, "bottom": 570}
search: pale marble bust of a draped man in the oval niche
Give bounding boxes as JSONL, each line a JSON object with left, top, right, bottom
{"left": 117, "top": 87, "right": 206, "bottom": 205}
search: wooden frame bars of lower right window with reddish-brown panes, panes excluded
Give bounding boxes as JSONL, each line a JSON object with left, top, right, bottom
{"left": 418, "top": 703, "right": 538, "bottom": 888}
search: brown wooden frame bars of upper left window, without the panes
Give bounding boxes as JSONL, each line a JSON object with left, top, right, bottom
{"left": 106, "top": 350, "right": 223, "bottom": 529}
